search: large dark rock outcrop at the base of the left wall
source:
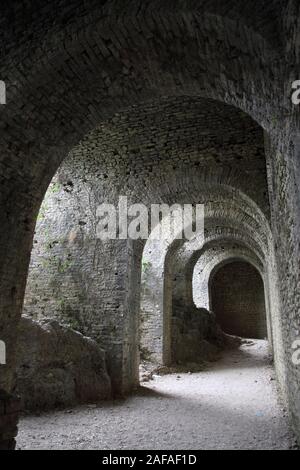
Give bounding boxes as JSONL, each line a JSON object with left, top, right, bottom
{"left": 17, "top": 317, "right": 111, "bottom": 411}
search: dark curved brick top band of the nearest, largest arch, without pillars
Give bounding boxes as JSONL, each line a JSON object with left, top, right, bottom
{"left": 2, "top": 7, "right": 280, "bottom": 210}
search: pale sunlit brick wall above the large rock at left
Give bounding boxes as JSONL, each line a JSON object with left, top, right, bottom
{"left": 24, "top": 161, "right": 137, "bottom": 393}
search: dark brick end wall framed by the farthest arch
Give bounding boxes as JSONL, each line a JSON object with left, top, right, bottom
{"left": 209, "top": 260, "right": 267, "bottom": 339}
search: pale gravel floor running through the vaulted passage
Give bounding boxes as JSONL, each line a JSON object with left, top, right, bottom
{"left": 18, "top": 341, "right": 295, "bottom": 450}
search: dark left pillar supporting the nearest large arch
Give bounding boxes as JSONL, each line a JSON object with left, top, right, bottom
{"left": 0, "top": 163, "right": 45, "bottom": 450}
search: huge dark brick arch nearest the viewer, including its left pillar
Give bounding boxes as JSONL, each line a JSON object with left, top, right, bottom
{"left": 0, "top": 1, "right": 300, "bottom": 448}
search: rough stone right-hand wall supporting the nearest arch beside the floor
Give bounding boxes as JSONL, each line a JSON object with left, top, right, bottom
{"left": 267, "top": 124, "right": 300, "bottom": 439}
